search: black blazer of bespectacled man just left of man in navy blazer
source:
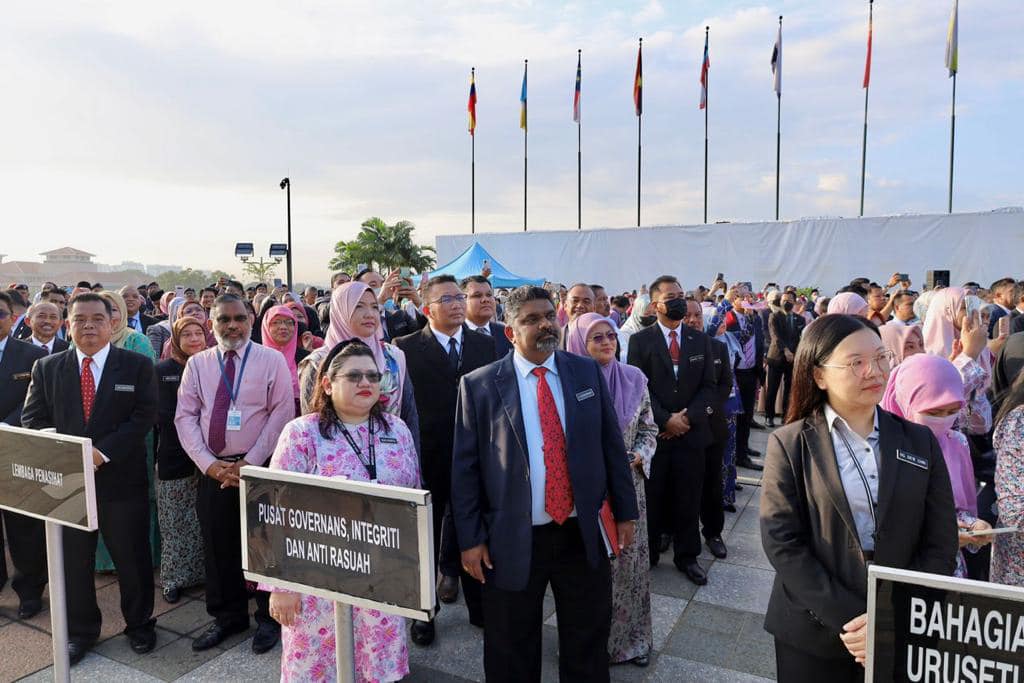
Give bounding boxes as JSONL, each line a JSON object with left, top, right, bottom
{"left": 393, "top": 325, "right": 497, "bottom": 500}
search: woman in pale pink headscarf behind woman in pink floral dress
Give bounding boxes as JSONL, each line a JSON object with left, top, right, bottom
{"left": 298, "top": 282, "right": 420, "bottom": 453}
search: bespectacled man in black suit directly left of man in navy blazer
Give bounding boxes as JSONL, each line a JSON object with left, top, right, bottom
{"left": 394, "top": 275, "right": 496, "bottom": 645}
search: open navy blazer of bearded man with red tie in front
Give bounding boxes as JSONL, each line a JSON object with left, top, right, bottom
{"left": 452, "top": 351, "right": 639, "bottom": 591}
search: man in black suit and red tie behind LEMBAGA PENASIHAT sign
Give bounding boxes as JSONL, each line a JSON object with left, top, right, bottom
{"left": 22, "top": 293, "right": 157, "bottom": 664}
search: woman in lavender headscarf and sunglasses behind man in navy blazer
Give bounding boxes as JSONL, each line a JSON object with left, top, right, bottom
{"left": 566, "top": 313, "right": 657, "bottom": 667}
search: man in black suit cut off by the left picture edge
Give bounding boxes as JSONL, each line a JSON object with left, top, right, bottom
{"left": 0, "top": 292, "right": 49, "bottom": 618}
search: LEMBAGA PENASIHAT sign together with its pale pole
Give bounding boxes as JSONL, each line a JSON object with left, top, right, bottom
{"left": 0, "top": 425, "right": 97, "bottom": 681}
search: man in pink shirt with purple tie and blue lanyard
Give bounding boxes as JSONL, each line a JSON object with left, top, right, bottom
{"left": 174, "top": 294, "right": 295, "bottom": 654}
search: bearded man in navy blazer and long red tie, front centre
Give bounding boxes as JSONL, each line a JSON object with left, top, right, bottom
{"left": 452, "top": 287, "right": 637, "bottom": 682}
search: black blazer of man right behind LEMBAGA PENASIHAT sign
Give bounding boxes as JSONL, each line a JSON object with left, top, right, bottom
{"left": 22, "top": 345, "right": 157, "bottom": 501}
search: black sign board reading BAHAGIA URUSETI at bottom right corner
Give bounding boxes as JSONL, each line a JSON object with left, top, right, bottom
{"left": 866, "top": 565, "right": 1024, "bottom": 683}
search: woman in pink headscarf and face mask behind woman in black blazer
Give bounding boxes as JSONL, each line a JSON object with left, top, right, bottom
{"left": 882, "top": 353, "right": 991, "bottom": 578}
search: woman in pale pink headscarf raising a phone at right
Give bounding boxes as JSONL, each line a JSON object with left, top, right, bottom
{"left": 923, "top": 287, "right": 992, "bottom": 434}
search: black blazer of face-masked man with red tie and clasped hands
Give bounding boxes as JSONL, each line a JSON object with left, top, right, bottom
{"left": 629, "top": 324, "right": 718, "bottom": 449}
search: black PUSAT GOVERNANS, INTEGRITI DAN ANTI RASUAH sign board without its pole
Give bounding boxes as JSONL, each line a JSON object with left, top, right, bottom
{"left": 241, "top": 466, "right": 434, "bottom": 620}
